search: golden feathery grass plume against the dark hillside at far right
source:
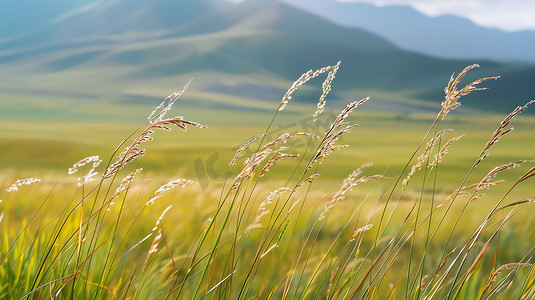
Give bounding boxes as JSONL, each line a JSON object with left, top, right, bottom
{"left": 438, "top": 64, "right": 500, "bottom": 120}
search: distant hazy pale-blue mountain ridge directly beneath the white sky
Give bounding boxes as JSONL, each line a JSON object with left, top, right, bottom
{"left": 278, "top": 0, "right": 535, "bottom": 63}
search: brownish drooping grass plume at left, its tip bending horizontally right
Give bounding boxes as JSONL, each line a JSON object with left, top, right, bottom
{"left": 104, "top": 117, "right": 206, "bottom": 178}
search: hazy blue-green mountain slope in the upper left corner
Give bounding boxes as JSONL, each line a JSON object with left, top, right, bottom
{"left": 0, "top": 0, "right": 231, "bottom": 49}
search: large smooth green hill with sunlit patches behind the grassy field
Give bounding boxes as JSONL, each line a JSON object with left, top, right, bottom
{"left": 0, "top": 0, "right": 535, "bottom": 116}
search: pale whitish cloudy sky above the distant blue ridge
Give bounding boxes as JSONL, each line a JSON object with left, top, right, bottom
{"left": 335, "top": 0, "right": 535, "bottom": 31}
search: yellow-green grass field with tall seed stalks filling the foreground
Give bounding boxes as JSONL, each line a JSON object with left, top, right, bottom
{"left": 0, "top": 62, "right": 535, "bottom": 299}
